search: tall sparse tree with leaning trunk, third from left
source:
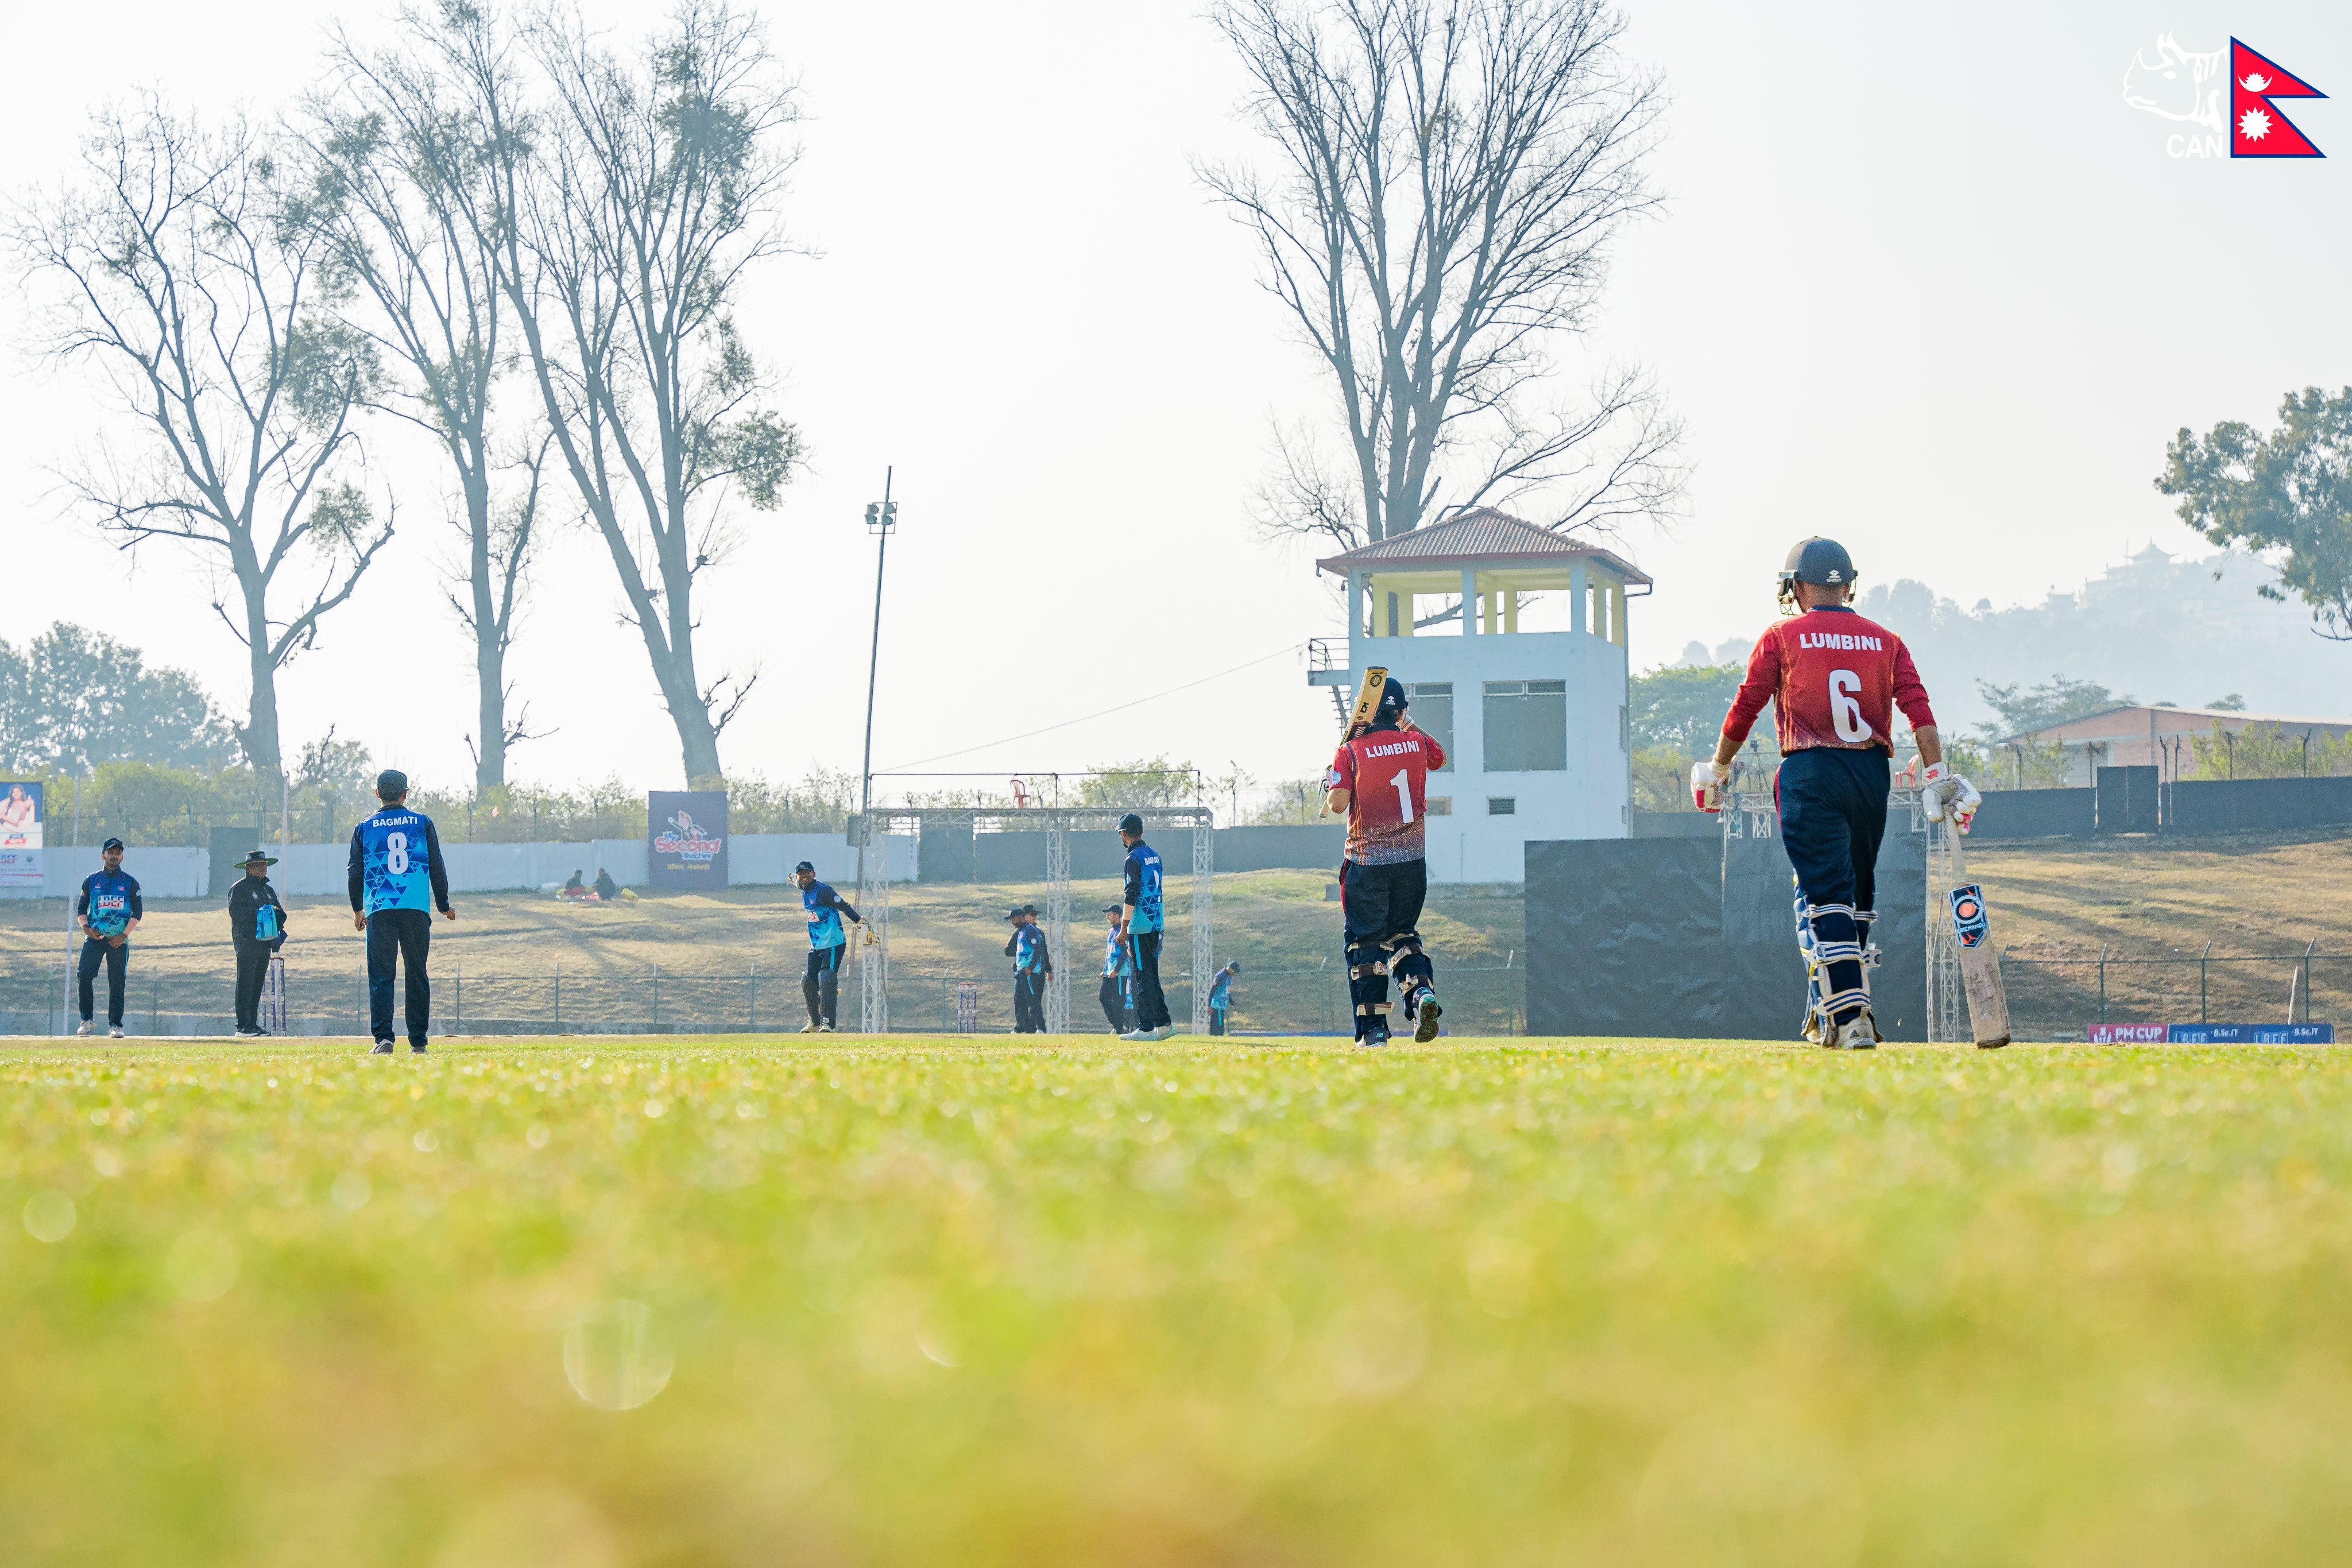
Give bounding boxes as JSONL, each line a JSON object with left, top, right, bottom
{"left": 501, "top": 0, "right": 800, "bottom": 780}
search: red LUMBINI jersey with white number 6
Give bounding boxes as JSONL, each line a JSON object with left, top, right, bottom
{"left": 1724, "top": 609, "right": 1936, "bottom": 754}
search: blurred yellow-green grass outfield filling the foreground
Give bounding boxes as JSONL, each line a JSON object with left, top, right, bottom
{"left": 0, "top": 1037, "right": 2352, "bottom": 1568}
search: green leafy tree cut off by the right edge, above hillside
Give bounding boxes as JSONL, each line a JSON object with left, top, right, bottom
{"left": 2157, "top": 385, "right": 2352, "bottom": 642}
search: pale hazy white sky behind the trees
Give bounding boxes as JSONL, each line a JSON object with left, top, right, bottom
{"left": 0, "top": 0, "right": 2352, "bottom": 804}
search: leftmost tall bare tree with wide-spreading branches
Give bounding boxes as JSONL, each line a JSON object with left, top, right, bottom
{"left": 11, "top": 96, "right": 393, "bottom": 773}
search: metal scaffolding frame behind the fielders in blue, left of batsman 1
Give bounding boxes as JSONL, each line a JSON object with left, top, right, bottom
{"left": 854, "top": 806, "right": 1216, "bottom": 1035}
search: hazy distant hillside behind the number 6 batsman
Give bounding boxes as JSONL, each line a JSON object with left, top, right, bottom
{"left": 1682, "top": 545, "right": 2352, "bottom": 729}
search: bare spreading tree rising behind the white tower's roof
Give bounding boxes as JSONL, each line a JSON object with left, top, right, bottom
{"left": 1202, "top": 0, "right": 1684, "bottom": 548}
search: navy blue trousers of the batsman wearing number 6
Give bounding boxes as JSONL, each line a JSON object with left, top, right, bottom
{"left": 1773, "top": 745, "right": 1893, "bottom": 1023}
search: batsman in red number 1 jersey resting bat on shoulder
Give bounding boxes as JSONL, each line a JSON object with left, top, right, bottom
{"left": 1324, "top": 679, "right": 1446, "bottom": 1046}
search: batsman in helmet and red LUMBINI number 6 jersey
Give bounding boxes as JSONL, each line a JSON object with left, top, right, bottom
{"left": 1691, "top": 539, "right": 1980, "bottom": 1051}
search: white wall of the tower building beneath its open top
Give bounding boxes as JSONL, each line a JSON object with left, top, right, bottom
{"left": 1350, "top": 632, "right": 1633, "bottom": 881}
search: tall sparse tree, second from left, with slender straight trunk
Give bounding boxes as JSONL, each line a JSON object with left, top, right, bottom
{"left": 296, "top": 5, "right": 546, "bottom": 790}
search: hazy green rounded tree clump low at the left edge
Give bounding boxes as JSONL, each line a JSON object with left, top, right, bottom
{"left": 0, "top": 621, "right": 238, "bottom": 773}
